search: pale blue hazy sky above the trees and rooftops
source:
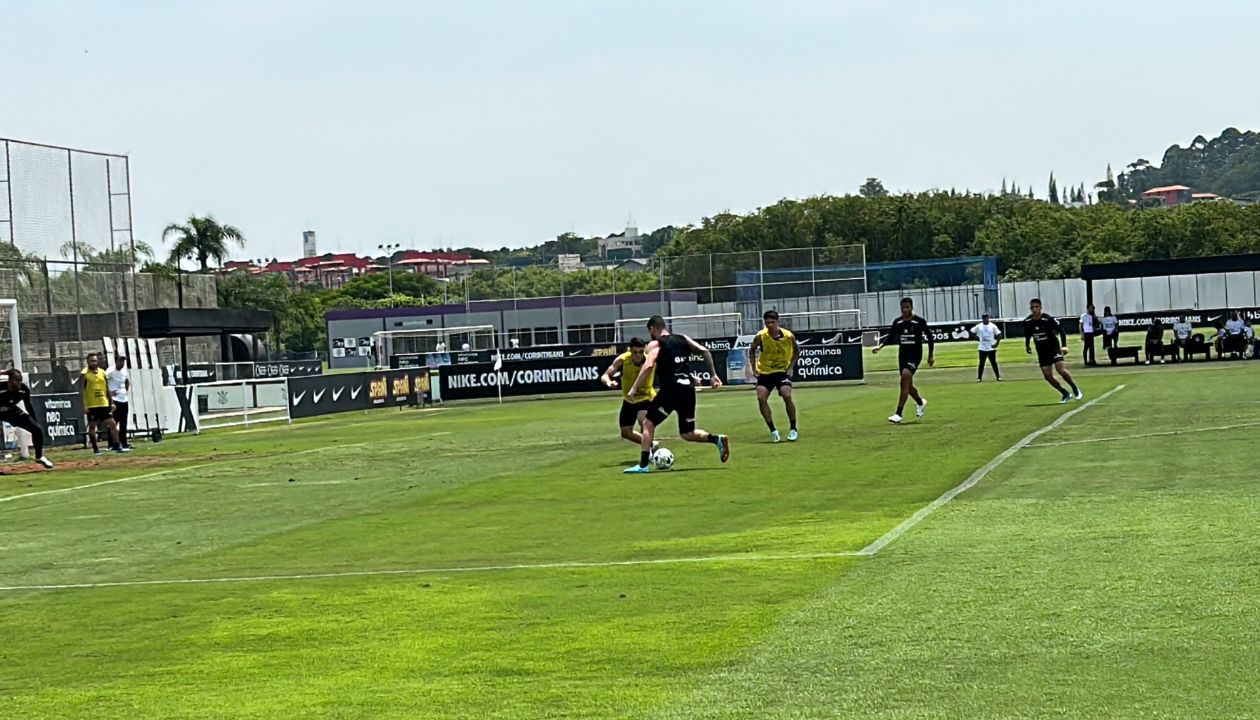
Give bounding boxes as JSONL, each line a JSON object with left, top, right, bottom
{"left": 0, "top": 0, "right": 1260, "bottom": 258}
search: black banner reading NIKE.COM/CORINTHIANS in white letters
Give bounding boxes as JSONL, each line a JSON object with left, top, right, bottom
{"left": 440, "top": 353, "right": 611, "bottom": 402}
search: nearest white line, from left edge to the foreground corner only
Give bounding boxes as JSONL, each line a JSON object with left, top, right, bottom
{"left": 0, "top": 551, "right": 861, "bottom": 593}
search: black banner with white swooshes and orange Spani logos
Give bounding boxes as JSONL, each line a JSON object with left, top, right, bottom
{"left": 289, "top": 368, "right": 430, "bottom": 419}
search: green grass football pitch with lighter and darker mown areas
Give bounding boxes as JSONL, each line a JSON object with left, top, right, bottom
{"left": 0, "top": 355, "right": 1260, "bottom": 720}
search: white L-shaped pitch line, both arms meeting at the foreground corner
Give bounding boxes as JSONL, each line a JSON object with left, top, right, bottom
{"left": 0, "top": 385, "right": 1125, "bottom": 593}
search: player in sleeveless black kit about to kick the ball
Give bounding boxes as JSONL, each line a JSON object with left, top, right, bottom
{"left": 625, "top": 315, "right": 731, "bottom": 473}
